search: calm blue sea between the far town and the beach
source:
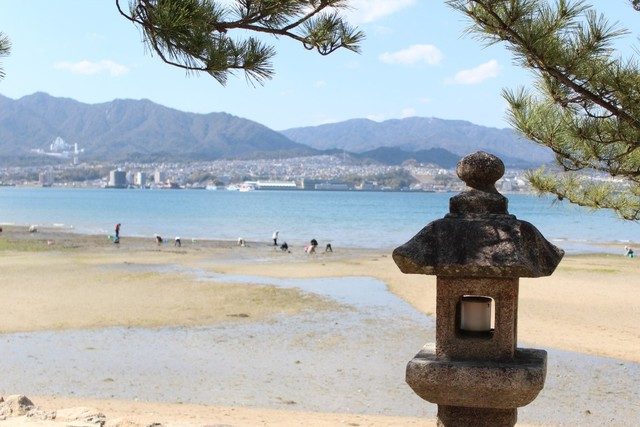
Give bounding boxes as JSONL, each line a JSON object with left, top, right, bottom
{"left": 0, "top": 187, "right": 640, "bottom": 252}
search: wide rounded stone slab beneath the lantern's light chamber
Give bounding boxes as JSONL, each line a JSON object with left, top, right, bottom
{"left": 406, "top": 346, "right": 547, "bottom": 409}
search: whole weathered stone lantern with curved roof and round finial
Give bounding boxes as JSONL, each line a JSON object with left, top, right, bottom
{"left": 393, "top": 152, "right": 564, "bottom": 426}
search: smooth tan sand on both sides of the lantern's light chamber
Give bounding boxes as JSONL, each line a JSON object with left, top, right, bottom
{"left": 205, "top": 246, "right": 640, "bottom": 362}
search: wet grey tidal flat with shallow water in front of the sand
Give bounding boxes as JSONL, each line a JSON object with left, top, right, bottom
{"left": 0, "top": 271, "right": 640, "bottom": 425}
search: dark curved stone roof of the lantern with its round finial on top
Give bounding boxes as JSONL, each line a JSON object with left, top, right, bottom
{"left": 393, "top": 152, "right": 564, "bottom": 277}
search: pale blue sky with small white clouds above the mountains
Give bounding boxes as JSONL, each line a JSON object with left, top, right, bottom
{"left": 0, "top": 0, "right": 640, "bottom": 130}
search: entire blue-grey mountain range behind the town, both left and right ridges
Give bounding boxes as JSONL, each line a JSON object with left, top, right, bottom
{"left": 0, "top": 92, "right": 552, "bottom": 167}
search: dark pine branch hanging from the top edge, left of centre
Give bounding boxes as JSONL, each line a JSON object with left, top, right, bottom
{"left": 116, "top": 0, "right": 364, "bottom": 85}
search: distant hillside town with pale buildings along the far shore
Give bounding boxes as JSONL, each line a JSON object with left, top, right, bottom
{"left": 0, "top": 155, "right": 529, "bottom": 192}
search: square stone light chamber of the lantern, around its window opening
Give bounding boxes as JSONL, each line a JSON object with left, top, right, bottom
{"left": 436, "top": 277, "right": 518, "bottom": 360}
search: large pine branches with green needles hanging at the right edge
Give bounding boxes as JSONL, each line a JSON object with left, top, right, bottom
{"left": 447, "top": 0, "right": 640, "bottom": 220}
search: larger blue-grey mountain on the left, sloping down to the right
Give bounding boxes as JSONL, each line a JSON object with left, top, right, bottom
{"left": 0, "top": 93, "right": 317, "bottom": 165}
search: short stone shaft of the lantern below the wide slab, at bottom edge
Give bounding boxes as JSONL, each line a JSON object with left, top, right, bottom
{"left": 438, "top": 405, "right": 518, "bottom": 427}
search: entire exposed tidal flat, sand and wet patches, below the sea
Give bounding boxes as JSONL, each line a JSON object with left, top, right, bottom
{"left": 0, "top": 236, "right": 640, "bottom": 426}
